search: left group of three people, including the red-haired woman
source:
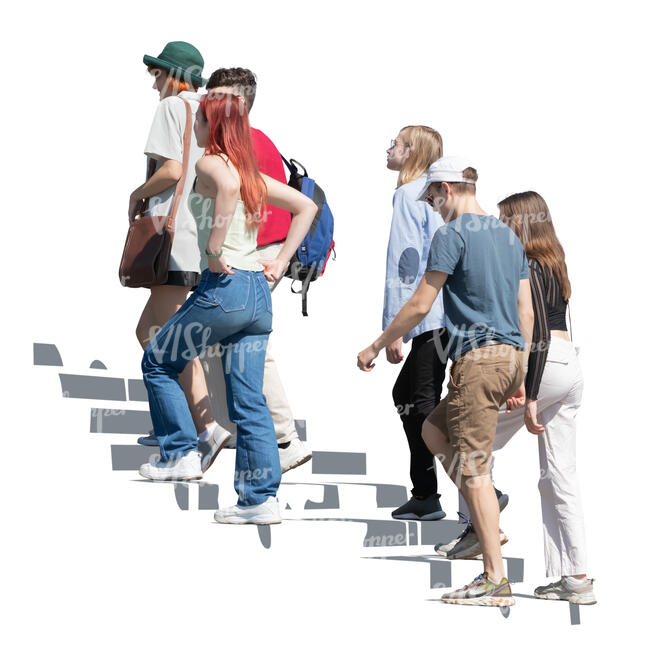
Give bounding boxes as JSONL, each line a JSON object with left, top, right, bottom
{"left": 129, "top": 41, "right": 317, "bottom": 524}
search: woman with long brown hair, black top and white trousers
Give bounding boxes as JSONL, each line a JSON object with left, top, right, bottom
{"left": 440, "top": 191, "right": 596, "bottom": 605}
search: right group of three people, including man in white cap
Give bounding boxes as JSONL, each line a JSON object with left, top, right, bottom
{"left": 357, "top": 126, "right": 596, "bottom": 606}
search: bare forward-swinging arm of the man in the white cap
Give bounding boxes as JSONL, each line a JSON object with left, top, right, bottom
{"left": 357, "top": 271, "right": 448, "bottom": 370}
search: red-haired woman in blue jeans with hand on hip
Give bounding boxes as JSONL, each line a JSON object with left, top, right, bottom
{"left": 140, "top": 93, "right": 317, "bottom": 524}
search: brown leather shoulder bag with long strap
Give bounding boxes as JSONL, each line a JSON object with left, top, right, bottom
{"left": 119, "top": 97, "right": 192, "bottom": 287}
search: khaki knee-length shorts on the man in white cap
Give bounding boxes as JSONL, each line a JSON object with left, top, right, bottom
{"left": 427, "top": 344, "right": 524, "bottom": 476}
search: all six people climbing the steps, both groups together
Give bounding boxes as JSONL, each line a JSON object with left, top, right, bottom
{"left": 129, "top": 41, "right": 595, "bottom": 605}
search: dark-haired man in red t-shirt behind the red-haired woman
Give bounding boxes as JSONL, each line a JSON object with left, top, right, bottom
{"left": 206, "top": 68, "right": 311, "bottom": 472}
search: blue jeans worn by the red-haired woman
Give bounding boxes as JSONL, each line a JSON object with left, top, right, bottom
{"left": 142, "top": 269, "right": 282, "bottom": 505}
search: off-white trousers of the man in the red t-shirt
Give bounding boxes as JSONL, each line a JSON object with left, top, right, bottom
{"left": 201, "top": 244, "right": 298, "bottom": 444}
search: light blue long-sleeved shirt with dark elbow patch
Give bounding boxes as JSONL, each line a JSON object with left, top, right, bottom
{"left": 382, "top": 174, "right": 445, "bottom": 343}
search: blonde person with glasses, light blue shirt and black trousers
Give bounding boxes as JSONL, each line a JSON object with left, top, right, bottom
{"left": 382, "top": 126, "right": 447, "bottom": 521}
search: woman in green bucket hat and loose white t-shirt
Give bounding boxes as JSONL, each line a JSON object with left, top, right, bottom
{"left": 129, "top": 41, "right": 227, "bottom": 445}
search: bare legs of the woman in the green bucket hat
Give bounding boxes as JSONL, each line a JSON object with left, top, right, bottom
{"left": 136, "top": 285, "right": 214, "bottom": 433}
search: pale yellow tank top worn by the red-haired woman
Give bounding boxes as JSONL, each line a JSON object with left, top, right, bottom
{"left": 188, "top": 188, "right": 264, "bottom": 271}
